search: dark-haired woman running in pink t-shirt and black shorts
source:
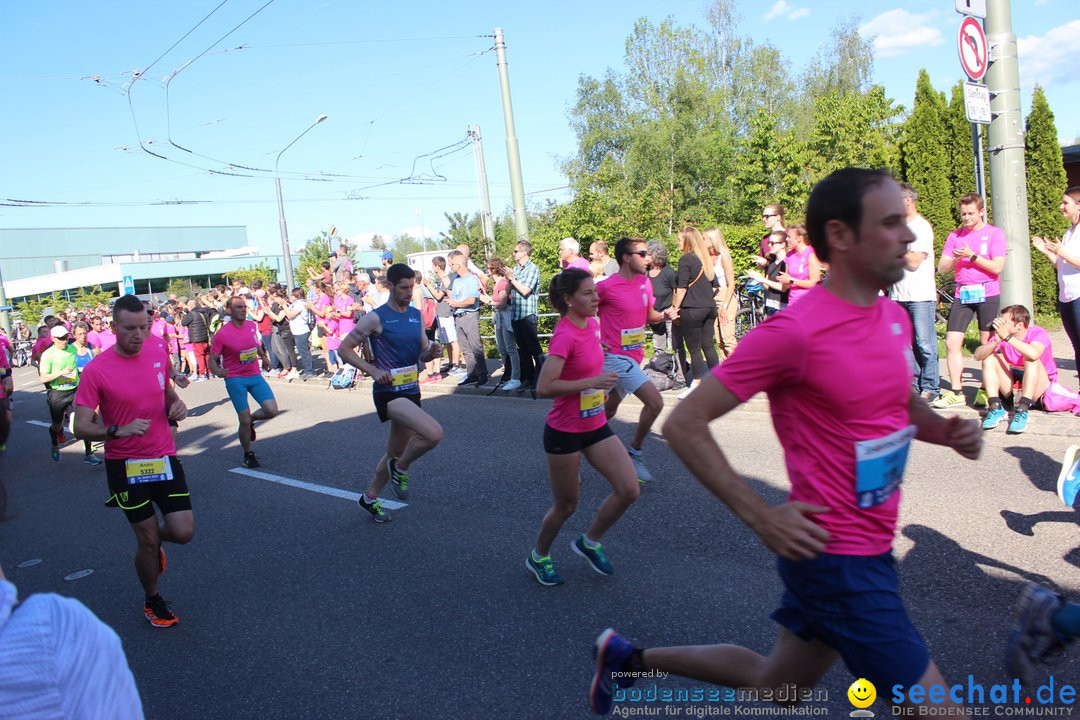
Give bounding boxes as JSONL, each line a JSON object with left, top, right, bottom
{"left": 525, "top": 268, "right": 640, "bottom": 585}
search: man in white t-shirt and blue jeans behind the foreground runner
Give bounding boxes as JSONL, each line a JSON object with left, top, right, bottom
{"left": 889, "top": 182, "right": 941, "bottom": 400}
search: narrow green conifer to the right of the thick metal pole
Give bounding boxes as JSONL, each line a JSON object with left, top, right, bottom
{"left": 1024, "top": 85, "right": 1068, "bottom": 313}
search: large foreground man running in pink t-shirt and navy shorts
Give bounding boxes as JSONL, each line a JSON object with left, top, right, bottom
{"left": 590, "top": 168, "right": 983, "bottom": 714}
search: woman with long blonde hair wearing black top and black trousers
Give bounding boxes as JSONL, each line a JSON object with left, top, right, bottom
{"left": 674, "top": 226, "right": 720, "bottom": 398}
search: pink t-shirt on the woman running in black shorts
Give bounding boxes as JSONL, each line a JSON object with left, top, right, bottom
{"left": 548, "top": 317, "right": 607, "bottom": 433}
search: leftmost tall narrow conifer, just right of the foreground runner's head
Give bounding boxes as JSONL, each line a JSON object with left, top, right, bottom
{"left": 900, "top": 69, "right": 956, "bottom": 254}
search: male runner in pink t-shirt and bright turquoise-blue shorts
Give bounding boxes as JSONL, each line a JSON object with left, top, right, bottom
{"left": 208, "top": 297, "right": 278, "bottom": 467}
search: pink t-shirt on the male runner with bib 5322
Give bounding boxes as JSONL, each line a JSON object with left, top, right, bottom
{"left": 75, "top": 343, "right": 176, "bottom": 460}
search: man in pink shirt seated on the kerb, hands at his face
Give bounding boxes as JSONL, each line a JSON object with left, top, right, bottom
{"left": 975, "top": 305, "right": 1057, "bottom": 434}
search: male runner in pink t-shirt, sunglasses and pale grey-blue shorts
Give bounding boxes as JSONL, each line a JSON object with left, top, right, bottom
{"left": 596, "top": 237, "right": 674, "bottom": 483}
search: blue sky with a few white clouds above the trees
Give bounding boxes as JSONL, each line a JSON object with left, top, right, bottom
{"left": 0, "top": 0, "right": 1080, "bottom": 252}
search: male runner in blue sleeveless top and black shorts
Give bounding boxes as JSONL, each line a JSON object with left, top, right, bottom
{"left": 338, "top": 262, "right": 443, "bottom": 522}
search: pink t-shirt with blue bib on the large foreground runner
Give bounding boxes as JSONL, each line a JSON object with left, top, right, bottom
{"left": 713, "top": 285, "right": 912, "bottom": 555}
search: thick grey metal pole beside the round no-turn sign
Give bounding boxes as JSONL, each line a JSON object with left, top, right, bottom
{"left": 986, "top": 0, "right": 1035, "bottom": 311}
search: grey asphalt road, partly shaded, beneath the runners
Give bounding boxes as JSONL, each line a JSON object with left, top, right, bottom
{"left": 0, "top": 369, "right": 1080, "bottom": 720}
